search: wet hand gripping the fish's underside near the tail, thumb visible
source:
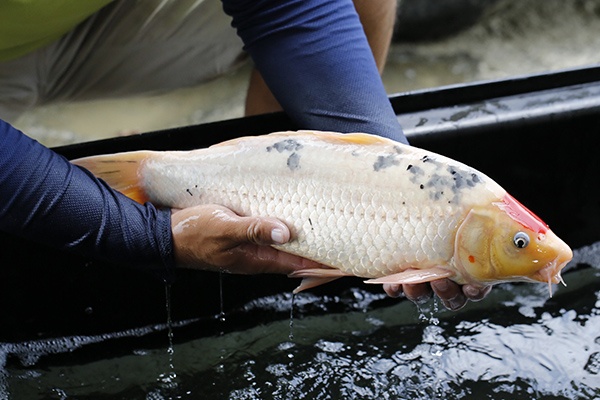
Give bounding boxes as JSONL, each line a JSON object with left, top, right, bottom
{"left": 171, "top": 204, "right": 321, "bottom": 275}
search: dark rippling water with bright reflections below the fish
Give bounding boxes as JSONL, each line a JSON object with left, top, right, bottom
{"left": 0, "top": 243, "right": 600, "bottom": 399}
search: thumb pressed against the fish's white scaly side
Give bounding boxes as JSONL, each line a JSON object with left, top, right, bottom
{"left": 237, "top": 217, "right": 291, "bottom": 245}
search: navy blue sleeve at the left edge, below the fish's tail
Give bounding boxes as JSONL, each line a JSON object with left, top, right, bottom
{"left": 0, "top": 120, "right": 174, "bottom": 269}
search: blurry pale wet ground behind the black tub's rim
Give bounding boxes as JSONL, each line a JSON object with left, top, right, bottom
{"left": 15, "top": 0, "right": 600, "bottom": 146}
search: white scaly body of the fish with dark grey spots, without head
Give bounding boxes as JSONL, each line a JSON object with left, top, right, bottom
{"left": 141, "top": 133, "right": 498, "bottom": 278}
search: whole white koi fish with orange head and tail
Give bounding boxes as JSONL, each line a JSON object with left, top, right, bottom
{"left": 74, "top": 131, "right": 572, "bottom": 294}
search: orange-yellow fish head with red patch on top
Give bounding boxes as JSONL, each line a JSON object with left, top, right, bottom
{"left": 455, "top": 194, "right": 573, "bottom": 285}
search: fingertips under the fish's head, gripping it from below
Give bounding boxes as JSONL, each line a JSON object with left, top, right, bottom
{"left": 383, "top": 279, "right": 492, "bottom": 311}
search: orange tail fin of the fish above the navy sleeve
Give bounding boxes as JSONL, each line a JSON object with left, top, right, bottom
{"left": 72, "top": 151, "right": 153, "bottom": 203}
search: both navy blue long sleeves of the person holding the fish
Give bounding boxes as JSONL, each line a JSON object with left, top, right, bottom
{"left": 0, "top": 0, "right": 406, "bottom": 268}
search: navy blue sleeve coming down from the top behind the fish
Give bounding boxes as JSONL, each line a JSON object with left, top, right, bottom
{"left": 223, "top": 0, "right": 407, "bottom": 143}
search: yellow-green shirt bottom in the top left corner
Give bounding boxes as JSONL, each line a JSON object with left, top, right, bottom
{"left": 0, "top": 0, "right": 112, "bottom": 61}
